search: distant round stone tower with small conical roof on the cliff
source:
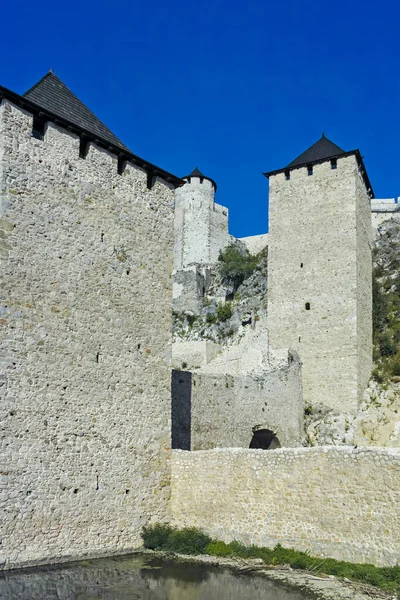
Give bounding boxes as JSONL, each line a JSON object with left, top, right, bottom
{"left": 173, "top": 167, "right": 230, "bottom": 313}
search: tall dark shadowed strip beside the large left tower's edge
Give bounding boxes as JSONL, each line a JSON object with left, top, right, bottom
{"left": 171, "top": 370, "right": 192, "bottom": 450}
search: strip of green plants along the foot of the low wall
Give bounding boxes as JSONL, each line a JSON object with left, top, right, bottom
{"left": 142, "top": 524, "right": 400, "bottom": 592}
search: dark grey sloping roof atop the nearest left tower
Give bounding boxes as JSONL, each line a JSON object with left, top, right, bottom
{"left": 24, "top": 71, "right": 128, "bottom": 150}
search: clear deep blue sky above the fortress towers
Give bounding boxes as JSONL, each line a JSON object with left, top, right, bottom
{"left": 0, "top": 0, "right": 400, "bottom": 236}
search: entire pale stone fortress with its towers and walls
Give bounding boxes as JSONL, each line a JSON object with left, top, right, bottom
{"left": 0, "top": 72, "right": 400, "bottom": 568}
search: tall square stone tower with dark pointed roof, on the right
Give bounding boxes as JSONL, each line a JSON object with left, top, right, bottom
{"left": 265, "top": 135, "right": 373, "bottom": 412}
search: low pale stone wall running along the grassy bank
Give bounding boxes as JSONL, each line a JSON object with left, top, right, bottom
{"left": 172, "top": 446, "right": 400, "bottom": 565}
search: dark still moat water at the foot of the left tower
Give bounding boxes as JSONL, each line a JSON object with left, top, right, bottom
{"left": 0, "top": 554, "right": 310, "bottom": 600}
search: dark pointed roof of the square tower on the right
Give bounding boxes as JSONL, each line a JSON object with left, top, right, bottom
{"left": 264, "top": 133, "right": 374, "bottom": 198}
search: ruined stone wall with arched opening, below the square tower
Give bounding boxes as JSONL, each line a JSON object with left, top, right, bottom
{"left": 172, "top": 357, "right": 304, "bottom": 450}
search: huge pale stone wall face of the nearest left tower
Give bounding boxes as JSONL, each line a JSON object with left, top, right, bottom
{"left": 0, "top": 102, "right": 174, "bottom": 567}
